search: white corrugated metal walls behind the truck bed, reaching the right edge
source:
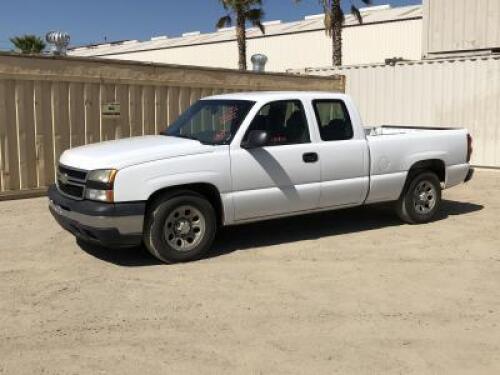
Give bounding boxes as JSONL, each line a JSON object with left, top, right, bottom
{"left": 296, "top": 0, "right": 500, "bottom": 168}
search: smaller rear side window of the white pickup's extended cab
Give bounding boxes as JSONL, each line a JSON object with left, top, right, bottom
{"left": 313, "top": 99, "right": 354, "bottom": 141}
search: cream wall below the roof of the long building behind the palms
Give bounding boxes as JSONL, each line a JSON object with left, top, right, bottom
{"left": 96, "top": 19, "right": 422, "bottom": 72}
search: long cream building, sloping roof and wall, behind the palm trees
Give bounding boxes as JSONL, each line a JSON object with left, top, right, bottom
{"left": 70, "top": 5, "right": 423, "bottom": 71}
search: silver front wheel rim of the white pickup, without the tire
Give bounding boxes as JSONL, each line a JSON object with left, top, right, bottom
{"left": 164, "top": 205, "right": 206, "bottom": 252}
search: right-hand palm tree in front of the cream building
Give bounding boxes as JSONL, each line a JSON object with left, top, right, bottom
{"left": 295, "top": 0, "right": 373, "bottom": 66}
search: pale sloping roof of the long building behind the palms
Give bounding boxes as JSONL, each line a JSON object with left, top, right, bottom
{"left": 68, "top": 5, "right": 423, "bottom": 56}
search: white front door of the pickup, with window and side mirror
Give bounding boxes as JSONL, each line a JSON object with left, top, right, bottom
{"left": 231, "top": 100, "right": 320, "bottom": 221}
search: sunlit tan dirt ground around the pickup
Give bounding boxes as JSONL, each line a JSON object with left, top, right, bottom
{"left": 0, "top": 171, "right": 500, "bottom": 374}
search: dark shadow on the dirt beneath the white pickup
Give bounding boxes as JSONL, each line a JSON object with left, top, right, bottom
{"left": 77, "top": 200, "right": 484, "bottom": 267}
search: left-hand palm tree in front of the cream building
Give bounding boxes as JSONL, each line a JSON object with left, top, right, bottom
{"left": 216, "top": 0, "right": 266, "bottom": 70}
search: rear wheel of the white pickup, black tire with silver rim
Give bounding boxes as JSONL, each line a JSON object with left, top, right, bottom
{"left": 396, "top": 171, "right": 441, "bottom": 224}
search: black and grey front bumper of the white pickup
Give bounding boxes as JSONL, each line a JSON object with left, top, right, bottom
{"left": 48, "top": 185, "right": 146, "bottom": 247}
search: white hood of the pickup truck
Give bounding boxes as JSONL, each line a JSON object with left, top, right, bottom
{"left": 59, "top": 135, "right": 214, "bottom": 170}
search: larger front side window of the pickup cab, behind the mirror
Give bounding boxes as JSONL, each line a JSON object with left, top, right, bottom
{"left": 243, "top": 100, "right": 311, "bottom": 146}
